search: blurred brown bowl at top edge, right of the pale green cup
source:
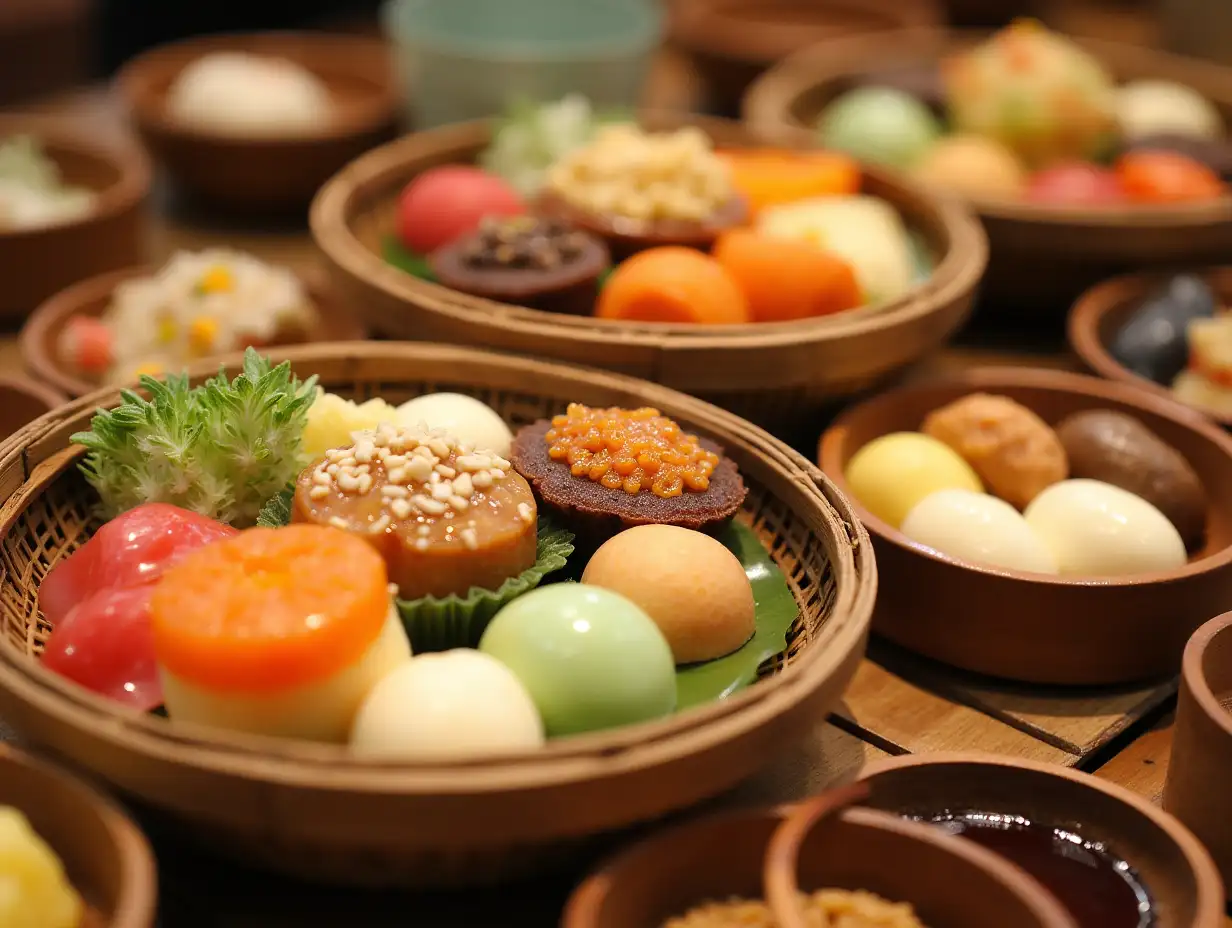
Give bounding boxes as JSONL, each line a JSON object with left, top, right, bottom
{"left": 668, "top": 0, "right": 942, "bottom": 113}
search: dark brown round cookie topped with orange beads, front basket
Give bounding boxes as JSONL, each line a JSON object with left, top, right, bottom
{"left": 510, "top": 403, "right": 748, "bottom": 542}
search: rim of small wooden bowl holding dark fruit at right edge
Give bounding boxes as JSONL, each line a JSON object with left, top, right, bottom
{"left": 1066, "top": 265, "right": 1232, "bottom": 428}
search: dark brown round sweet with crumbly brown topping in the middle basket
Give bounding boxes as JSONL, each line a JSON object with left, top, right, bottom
{"left": 429, "top": 216, "right": 611, "bottom": 313}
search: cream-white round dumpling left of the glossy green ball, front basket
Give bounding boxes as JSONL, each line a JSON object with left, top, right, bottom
{"left": 351, "top": 648, "right": 543, "bottom": 760}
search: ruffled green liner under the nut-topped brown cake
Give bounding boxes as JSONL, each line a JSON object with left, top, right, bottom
{"left": 397, "top": 516, "right": 573, "bottom": 654}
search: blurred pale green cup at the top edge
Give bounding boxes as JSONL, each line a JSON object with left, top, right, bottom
{"left": 382, "top": 0, "right": 663, "bottom": 129}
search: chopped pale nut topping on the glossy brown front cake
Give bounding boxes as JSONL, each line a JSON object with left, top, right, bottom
{"left": 308, "top": 425, "right": 537, "bottom": 547}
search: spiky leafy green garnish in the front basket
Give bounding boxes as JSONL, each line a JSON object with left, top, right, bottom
{"left": 73, "top": 349, "right": 317, "bottom": 526}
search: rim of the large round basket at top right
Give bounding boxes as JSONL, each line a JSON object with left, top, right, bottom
{"left": 742, "top": 30, "right": 1232, "bottom": 234}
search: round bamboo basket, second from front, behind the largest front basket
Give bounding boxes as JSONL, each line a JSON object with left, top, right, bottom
{"left": 312, "top": 115, "right": 987, "bottom": 439}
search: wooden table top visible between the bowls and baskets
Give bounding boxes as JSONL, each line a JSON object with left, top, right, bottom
{"left": 0, "top": 28, "right": 1232, "bottom": 928}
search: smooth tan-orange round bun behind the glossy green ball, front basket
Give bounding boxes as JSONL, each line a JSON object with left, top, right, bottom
{"left": 582, "top": 525, "right": 756, "bottom": 664}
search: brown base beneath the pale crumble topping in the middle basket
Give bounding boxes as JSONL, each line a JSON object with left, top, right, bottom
{"left": 538, "top": 192, "right": 749, "bottom": 260}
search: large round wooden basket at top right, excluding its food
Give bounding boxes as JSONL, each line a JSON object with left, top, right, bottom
{"left": 744, "top": 30, "right": 1232, "bottom": 320}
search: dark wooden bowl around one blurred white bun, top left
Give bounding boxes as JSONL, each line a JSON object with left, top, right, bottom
{"left": 117, "top": 32, "right": 398, "bottom": 213}
